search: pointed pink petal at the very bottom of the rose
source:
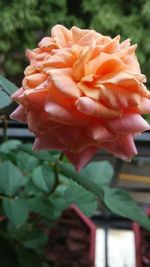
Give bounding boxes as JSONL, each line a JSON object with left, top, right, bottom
{"left": 64, "top": 146, "right": 97, "bottom": 172}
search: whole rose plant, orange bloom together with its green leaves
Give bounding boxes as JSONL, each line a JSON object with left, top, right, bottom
{"left": 0, "top": 22, "right": 150, "bottom": 267}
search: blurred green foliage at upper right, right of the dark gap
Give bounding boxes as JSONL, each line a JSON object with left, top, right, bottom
{"left": 82, "top": 0, "right": 150, "bottom": 83}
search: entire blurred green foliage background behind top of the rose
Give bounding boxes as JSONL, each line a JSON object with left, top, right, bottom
{"left": 0, "top": 0, "right": 150, "bottom": 86}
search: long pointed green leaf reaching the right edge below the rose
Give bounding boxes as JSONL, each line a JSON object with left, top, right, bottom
{"left": 104, "top": 187, "right": 150, "bottom": 230}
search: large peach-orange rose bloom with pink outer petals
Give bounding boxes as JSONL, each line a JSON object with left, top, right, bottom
{"left": 11, "top": 25, "right": 150, "bottom": 170}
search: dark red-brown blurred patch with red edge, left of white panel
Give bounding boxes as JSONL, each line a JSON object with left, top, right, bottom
{"left": 45, "top": 205, "right": 96, "bottom": 267}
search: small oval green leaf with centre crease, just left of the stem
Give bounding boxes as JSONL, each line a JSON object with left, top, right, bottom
{"left": 32, "top": 165, "right": 55, "bottom": 193}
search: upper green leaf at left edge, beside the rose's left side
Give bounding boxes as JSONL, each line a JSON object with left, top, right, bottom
{"left": 0, "top": 75, "right": 18, "bottom": 96}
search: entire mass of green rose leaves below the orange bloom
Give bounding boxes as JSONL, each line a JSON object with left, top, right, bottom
{"left": 0, "top": 140, "right": 150, "bottom": 267}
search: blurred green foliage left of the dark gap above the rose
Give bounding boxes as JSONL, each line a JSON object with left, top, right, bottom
{"left": 0, "top": 0, "right": 82, "bottom": 82}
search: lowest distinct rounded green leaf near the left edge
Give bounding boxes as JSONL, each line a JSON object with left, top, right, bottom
{"left": 3, "top": 198, "right": 28, "bottom": 226}
